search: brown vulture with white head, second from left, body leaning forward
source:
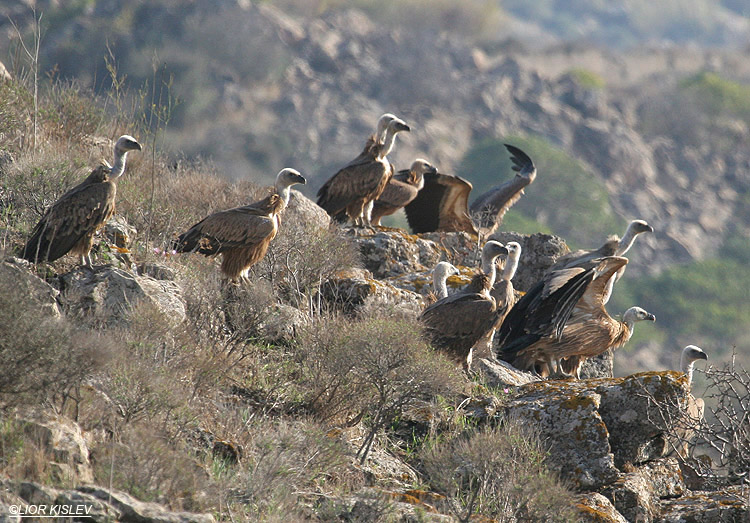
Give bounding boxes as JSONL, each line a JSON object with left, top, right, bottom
{"left": 172, "top": 168, "right": 306, "bottom": 283}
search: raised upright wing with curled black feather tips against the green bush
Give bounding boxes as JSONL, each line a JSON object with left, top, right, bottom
{"left": 470, "top": 144, "right": 536, "bottom": 234}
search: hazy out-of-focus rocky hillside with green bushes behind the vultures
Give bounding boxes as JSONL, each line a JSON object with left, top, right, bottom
{"left": 0, "top": 0, "right": 750, "bottom": 373}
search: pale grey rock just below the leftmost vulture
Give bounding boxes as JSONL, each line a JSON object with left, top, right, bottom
{"left": 60, "top": 266, "right": 186, "bottom": 325}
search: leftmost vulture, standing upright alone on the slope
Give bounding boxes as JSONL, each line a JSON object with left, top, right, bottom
{"left": 21, "top": 135, "right": 141, "bottom": 267}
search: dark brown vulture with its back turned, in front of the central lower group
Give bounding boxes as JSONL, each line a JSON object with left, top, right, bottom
{"left": 420, "top": 241, "right": 508, "bottom": 370}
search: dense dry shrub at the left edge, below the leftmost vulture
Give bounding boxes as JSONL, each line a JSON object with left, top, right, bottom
{"left": 0, "top": 279, "right": 108, "bottom": 410}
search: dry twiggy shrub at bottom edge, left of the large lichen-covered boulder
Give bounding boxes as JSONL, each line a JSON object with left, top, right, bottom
{"left": 422, "top": 419, "right": 575, "bottom": 522}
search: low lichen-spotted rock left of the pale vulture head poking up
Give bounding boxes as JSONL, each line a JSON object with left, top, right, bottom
{"left": 321, "top": 269, "right": 423, "bottom": 314}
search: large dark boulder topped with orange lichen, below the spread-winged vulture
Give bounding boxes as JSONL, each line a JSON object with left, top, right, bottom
{"left": 490, "top": 371, "right": 688, "bottom": 492}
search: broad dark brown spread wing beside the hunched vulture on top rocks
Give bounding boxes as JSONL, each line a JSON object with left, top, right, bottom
{"left": 404, "top": 173, "right": 477, "bottom": 234}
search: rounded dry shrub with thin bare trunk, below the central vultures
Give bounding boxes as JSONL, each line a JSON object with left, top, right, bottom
{"left": 301, "top": 317, "right": 460, "bottom": 462}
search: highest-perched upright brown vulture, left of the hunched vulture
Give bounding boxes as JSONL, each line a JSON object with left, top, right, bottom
{"left": 318, "top": 114, "right": 409, "bottom": 227}
